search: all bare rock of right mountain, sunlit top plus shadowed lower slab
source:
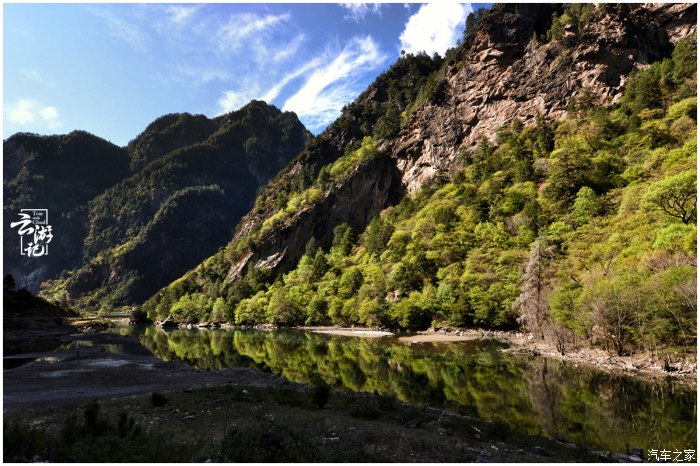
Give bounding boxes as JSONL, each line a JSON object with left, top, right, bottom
{"left": 219, "top": 4, "right": 697, "bottom": 283}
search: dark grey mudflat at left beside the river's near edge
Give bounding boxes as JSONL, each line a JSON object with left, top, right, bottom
{"left": 3, "top": 334, "right": 286, "bottom": 414}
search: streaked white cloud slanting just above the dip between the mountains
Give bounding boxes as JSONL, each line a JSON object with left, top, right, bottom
{"left": 283, "top": 36, "right": 386, "bottom": 130}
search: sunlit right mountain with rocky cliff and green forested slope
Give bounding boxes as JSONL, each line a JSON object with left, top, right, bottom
{"left": 144, "top": 4, "right": 697, "bottom": 354}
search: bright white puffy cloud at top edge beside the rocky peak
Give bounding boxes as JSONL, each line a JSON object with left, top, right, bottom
{"left": 399, "top": 2, "right": 473, "bottom": 55}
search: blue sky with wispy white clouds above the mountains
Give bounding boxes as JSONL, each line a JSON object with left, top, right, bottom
{"left": 3, "top": 0, "right": 481, "bottom": 145}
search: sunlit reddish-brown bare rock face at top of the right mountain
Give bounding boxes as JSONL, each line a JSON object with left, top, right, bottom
{"left": 394, "top": 4, "right": 697, "bottom": 192}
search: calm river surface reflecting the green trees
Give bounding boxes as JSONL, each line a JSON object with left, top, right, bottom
{"left": 116, "top": 327, "right": 697, "bottom": 452}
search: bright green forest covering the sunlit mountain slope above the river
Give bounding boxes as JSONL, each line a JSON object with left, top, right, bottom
{"left": 146, "top": 24, "right": 697, "bottom": 355}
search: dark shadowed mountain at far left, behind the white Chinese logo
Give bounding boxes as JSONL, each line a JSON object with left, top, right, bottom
{"left": 3, "top": 131, "right": 129, "bottom": 292}
